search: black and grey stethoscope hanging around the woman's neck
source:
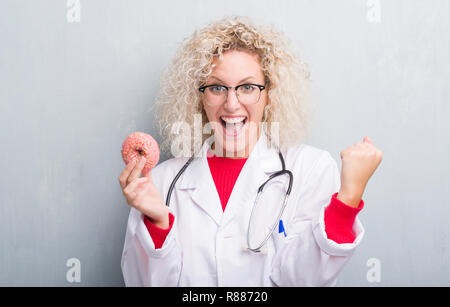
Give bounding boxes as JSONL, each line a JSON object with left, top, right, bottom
{"left": 166, "top": 151, "right": 293, "bottom": 253}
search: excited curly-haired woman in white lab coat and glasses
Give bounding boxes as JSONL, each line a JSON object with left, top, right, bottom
{"left": 119, "top": 18, "right": 382, "bottom": 286}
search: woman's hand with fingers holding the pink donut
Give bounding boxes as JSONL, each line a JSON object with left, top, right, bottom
{"left": 119, "top": 157, "right": 169, "bottom": 229}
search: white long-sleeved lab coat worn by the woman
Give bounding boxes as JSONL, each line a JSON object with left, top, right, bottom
{"left": 121, "top": 133, "right": 364, "bottom": 287}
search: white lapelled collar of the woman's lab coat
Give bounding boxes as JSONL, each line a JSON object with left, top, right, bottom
{"left": 178, "top": 131, "right": 282, "bottom": 227}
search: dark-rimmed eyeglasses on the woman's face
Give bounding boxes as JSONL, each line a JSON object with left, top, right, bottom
{"left": 198, "top": 83, "right": 266, "bottom": 106}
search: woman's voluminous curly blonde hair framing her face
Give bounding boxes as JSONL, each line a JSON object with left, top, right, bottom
{"left": 155, "top": 16, "right": 312, "bottom": 155}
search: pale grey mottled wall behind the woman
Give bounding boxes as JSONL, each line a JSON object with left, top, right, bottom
{"left": 0, "top": 0, "right": 450, "bottom": 286}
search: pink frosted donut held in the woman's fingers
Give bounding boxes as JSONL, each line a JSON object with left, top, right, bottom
{"left": 122, "top": 132, "right": 159, "bottom": 174}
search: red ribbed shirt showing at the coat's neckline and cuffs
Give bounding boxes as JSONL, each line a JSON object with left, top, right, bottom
{"left": 144, "top": 156, "right": 364, "bottom": 248}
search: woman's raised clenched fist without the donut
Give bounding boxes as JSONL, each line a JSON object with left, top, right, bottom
{"left": 337, "top": 136, "right": 383, "bottom": 207}
